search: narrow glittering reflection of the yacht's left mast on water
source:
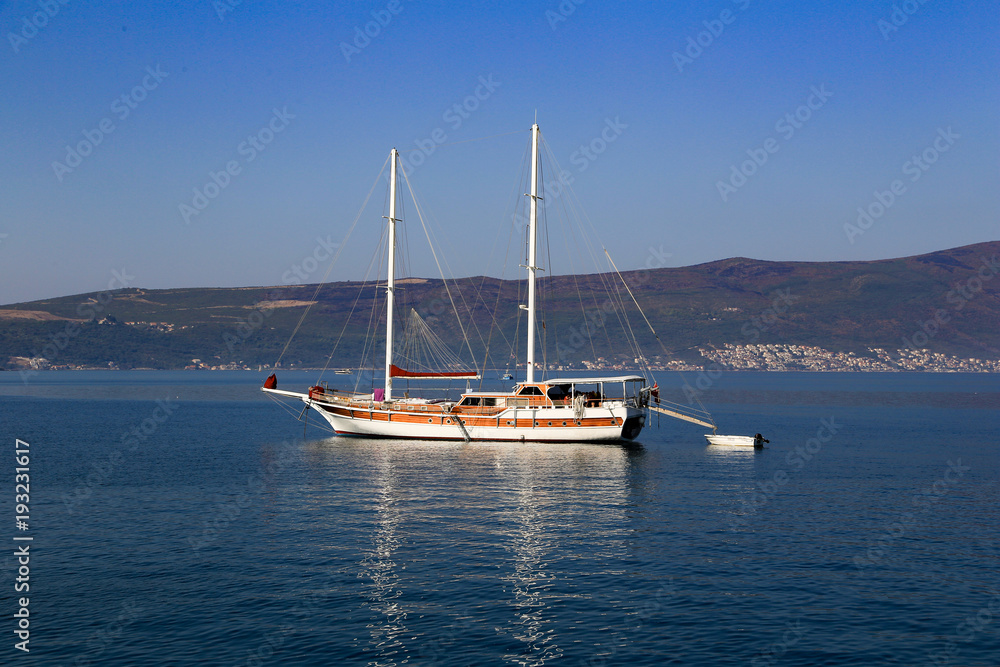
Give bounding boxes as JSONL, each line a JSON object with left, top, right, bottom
{"left": 358, "top": 447, "right": 409, "bottom": 667}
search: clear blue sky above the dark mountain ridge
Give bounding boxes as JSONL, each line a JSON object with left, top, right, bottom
{"left": 0, "top": 0, "right": 1000, "bottom": 303}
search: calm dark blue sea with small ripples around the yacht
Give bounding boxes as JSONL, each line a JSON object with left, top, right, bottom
{"left": 0, "top": 371, "right": 1000, "bottom": 666}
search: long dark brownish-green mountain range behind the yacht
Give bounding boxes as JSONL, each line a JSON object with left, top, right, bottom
{"left": 0, "top": 241, "right": 1000, "bottom": 369}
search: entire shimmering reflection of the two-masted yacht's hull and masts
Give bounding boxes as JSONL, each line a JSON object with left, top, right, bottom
{"left": 315, "top": 438, "right": 643, "bottom": 667}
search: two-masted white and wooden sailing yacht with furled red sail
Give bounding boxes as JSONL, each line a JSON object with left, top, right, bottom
{"left": 262, "top": 124, "right": 656, "bottom": 442}
